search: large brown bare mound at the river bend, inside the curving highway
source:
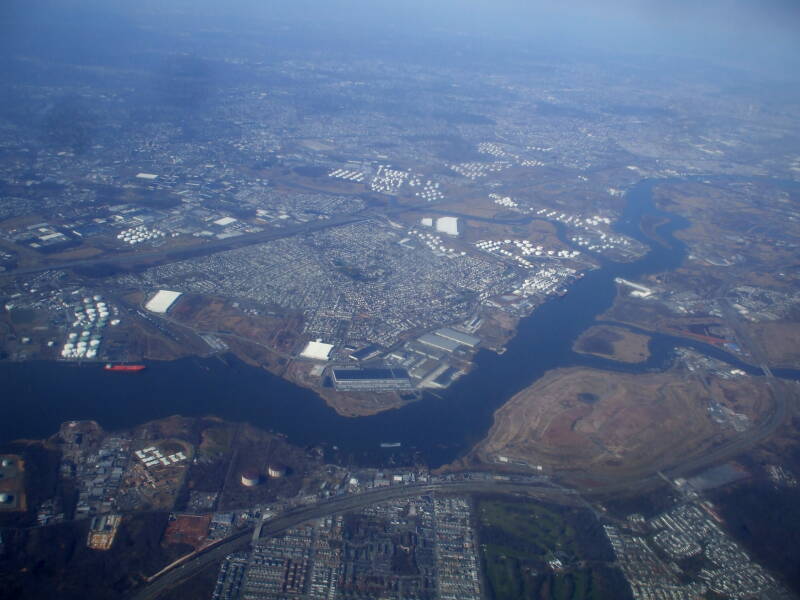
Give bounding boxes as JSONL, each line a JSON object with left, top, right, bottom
{"left": 473, "top": 368, "right": 771, "bottom": 488}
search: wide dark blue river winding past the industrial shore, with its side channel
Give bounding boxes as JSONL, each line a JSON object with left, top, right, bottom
{"left": 0, "top": 181, "right": 797, "bottom": 466}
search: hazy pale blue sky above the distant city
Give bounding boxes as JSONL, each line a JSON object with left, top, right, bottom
{"left": 0, "top": 0, "right": 800, "bottom": 80}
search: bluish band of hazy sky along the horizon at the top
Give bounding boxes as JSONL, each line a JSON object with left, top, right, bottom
{"left": 0, "top": 0, "right": 800, "bottom": 83}
